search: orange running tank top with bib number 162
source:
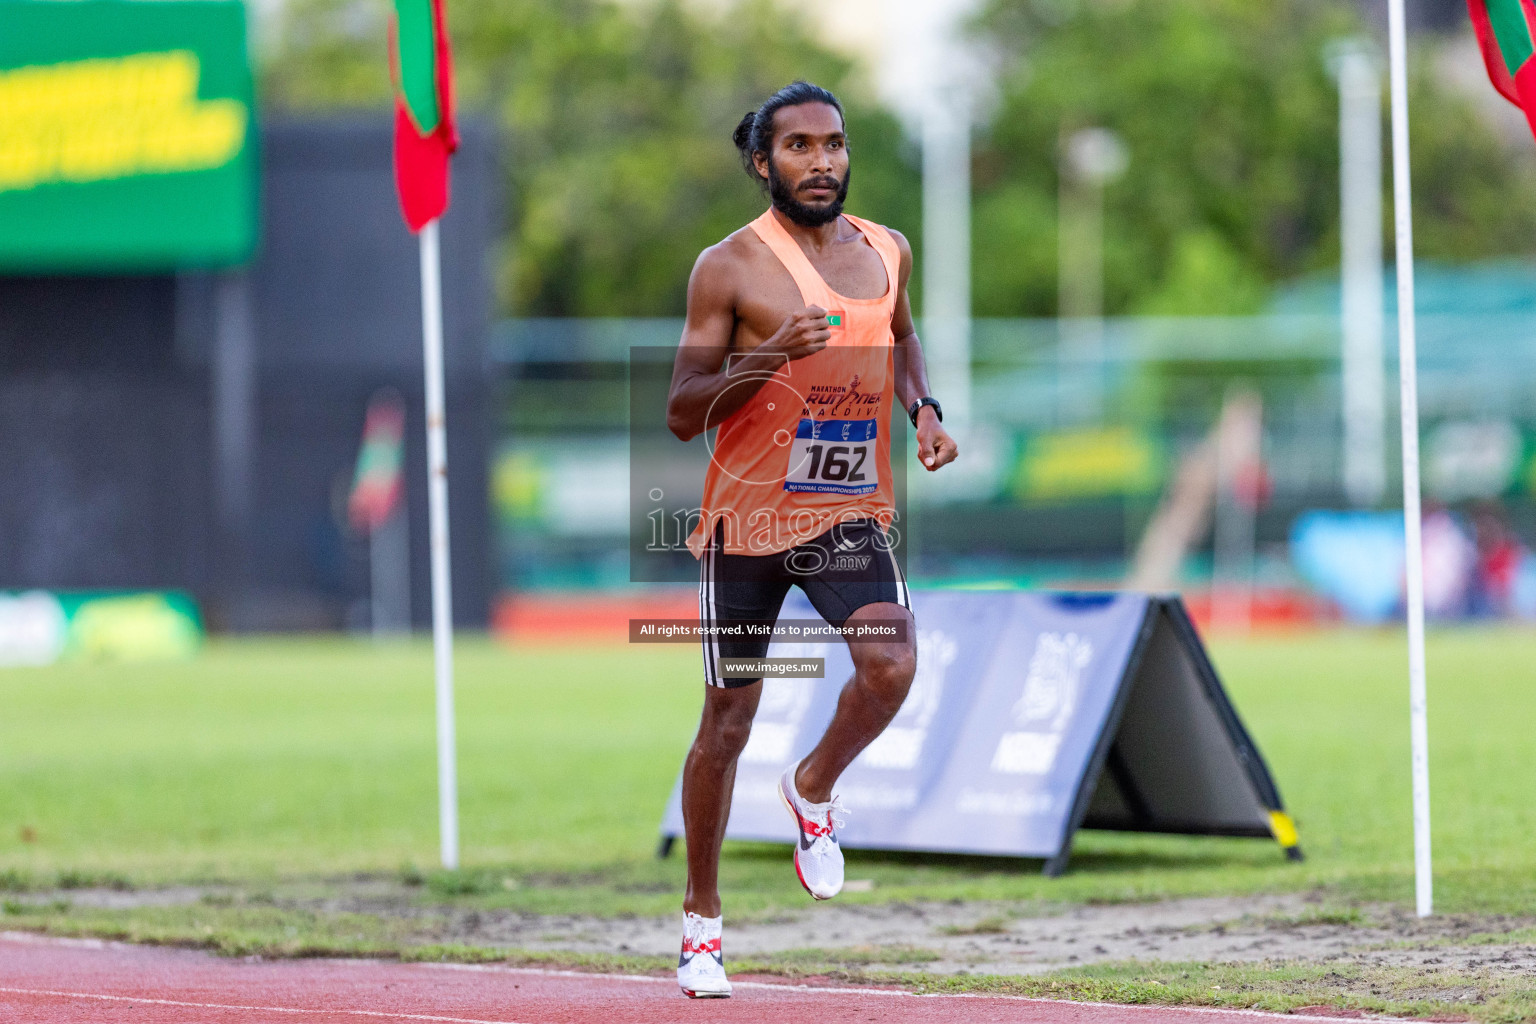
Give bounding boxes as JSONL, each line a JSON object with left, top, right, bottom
{"left": 688, "top": 209, "right": 902, "bottom": 557}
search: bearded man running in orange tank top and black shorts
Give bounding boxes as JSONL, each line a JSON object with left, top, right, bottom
{"left": 667, "top": 81, "right": 957, "bottom": 996}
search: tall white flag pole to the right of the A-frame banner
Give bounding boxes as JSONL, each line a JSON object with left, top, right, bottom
{"left": 1387, "top": 0, "right": 1435, "bottom": 918}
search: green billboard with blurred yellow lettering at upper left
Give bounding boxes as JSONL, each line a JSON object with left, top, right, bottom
{"left": 0, "top": 0, "right": 257, "bottom": 272}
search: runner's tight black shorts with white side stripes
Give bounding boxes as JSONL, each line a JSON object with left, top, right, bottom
{"left": 699, "top": 519, "right": 912, "bottom": 688}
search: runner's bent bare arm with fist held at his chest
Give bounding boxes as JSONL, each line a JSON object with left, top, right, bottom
{"left": 667, "top": 246, "right": 831, "bottom": 441}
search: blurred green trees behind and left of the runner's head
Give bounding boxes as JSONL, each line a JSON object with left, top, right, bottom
{"left": 263, "top": 0, "right": 919, "bottom": 316}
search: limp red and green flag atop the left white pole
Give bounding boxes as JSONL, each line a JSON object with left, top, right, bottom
{"left": 390, "top": 0, "right": 459, "bottom": 232}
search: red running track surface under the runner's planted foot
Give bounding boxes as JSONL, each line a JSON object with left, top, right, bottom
{"left": 0, "top": 933, "right": 1370, "bottom": 1024}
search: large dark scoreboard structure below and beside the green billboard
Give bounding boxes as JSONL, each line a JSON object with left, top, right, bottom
{"left": 0, "top": 114, "right": 501, "bottom": 631}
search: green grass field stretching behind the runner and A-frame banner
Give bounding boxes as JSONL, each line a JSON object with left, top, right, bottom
{"left": 0, "top": 628, "right": 1536, "bottom": 913}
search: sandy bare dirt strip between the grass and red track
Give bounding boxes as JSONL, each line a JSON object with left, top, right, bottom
{"left": 38, "top": 880, "right": 1536, "bottom": 975}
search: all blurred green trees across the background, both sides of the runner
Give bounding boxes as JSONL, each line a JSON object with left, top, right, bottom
{"left": 263, "top": 0, "right": 1536, "bottom": 316}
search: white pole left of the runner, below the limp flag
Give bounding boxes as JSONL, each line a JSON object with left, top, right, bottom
{"left": 421, "top": 220, "right": 459, "bottom": 870}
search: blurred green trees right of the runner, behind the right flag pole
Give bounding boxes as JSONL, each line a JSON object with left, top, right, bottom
{"left": 975, "top": 0, "right": 1536, "bottom": 315}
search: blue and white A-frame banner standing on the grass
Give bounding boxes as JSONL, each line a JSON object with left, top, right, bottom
{"left": 662, "top": 590, "right": 1301, "bottom": 875}
